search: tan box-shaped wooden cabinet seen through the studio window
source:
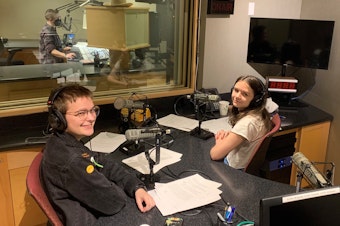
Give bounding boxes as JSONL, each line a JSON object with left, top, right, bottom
{"left": 86, "top": 6, "right": 150, "bottom": 51}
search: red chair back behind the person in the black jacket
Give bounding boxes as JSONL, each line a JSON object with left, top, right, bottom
{"left": 26, "top": 152, "right": 63, "bottom": 226}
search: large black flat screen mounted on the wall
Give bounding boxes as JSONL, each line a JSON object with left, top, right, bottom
{"left": 247, "top": 18, "right": 334, "bottom": 69}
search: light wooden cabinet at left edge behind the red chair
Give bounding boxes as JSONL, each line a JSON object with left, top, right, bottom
{"left": 0, "top": 147, "right": 47, "bottom": 226}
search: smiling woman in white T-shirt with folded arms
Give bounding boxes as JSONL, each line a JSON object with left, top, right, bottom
{"left": 210, "top": 75, "right": 272, "bottom": 169}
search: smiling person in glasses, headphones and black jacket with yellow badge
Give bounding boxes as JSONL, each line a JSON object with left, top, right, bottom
{"left": 41, "top": 85, "right": 155, "bottom": 225}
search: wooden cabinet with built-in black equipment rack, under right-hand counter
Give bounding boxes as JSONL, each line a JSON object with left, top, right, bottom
{"left": 262, "top": 121, "right": 331, "bottom": 187}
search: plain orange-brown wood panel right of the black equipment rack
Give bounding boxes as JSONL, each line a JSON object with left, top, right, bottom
{"left": 290, "top": 121, "right": 331, "bottom": 187}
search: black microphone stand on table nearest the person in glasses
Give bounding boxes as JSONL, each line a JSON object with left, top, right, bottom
{"left": 139, "top": 133, "right": 162, "bottom": 190}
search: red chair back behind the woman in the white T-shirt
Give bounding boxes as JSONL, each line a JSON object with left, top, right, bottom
{"left": 243, "top": 113, "right": 281, "bottom": 176}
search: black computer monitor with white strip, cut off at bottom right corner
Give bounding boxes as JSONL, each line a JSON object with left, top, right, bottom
{"left": 260, "top": 186, "right": 340, "bottom": 226}
